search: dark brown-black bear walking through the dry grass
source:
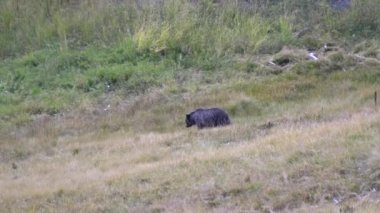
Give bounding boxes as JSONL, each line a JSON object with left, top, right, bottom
{"left": 186, "top": 108, "right": 231, "bottom": 129}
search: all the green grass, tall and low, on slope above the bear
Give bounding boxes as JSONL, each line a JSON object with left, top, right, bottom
{"left": 0, "top": 0, "right": 380, "bottom": 133}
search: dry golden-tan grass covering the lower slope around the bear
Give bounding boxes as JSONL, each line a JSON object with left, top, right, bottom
{"left": 0, "top": 71, "right": 380, "bottom": 212}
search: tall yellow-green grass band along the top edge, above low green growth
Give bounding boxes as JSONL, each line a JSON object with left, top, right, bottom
{"left": 0, "top": 0, "right": 380, "bottom": 57}
